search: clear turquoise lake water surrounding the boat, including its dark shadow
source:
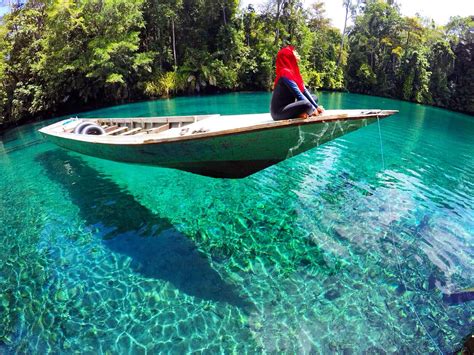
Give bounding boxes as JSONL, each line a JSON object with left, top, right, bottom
{"left": 0, "top": 93, "right": 474, "bottom": 354}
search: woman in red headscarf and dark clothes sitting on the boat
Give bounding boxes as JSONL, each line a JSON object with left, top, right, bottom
{"left": 270, "top": 46, "right": 324, "bottom": 121}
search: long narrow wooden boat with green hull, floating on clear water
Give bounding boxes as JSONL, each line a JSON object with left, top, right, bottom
{"left": 39, "top": 110, "right": 398, "bottom": 178}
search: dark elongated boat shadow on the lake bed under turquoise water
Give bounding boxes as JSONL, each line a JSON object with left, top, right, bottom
{"left": 36, "top": 149, "right": 250, "bottom": 307}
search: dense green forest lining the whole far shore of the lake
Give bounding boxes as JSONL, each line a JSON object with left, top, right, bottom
{"left": 0, "top": 0, "right": 474, "bottom": 127}
